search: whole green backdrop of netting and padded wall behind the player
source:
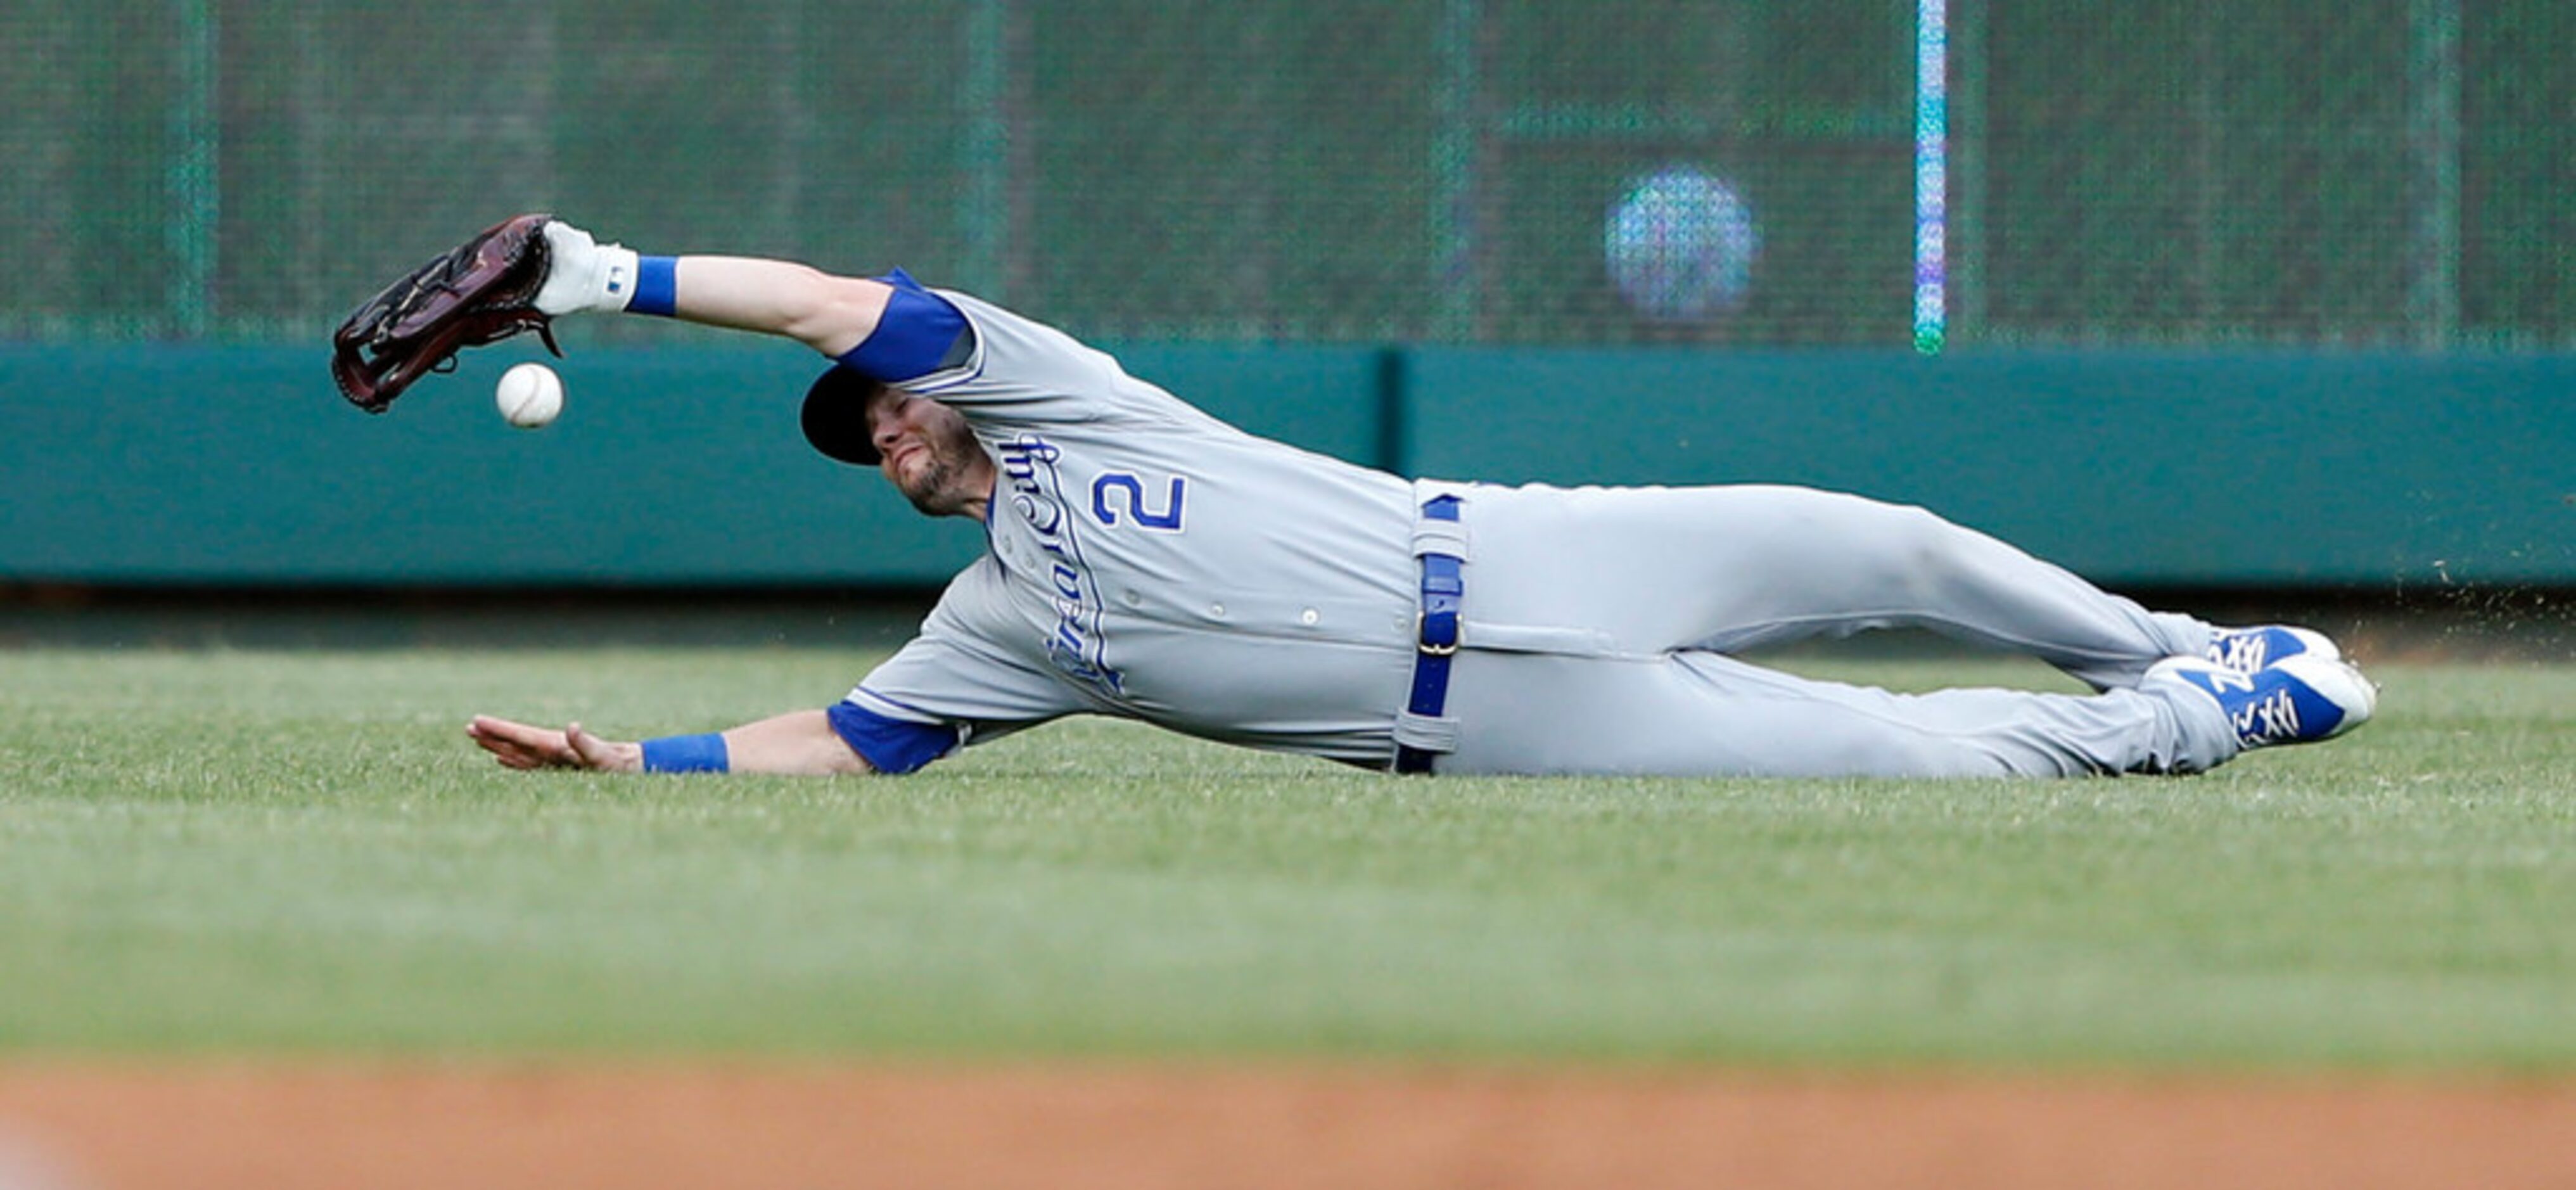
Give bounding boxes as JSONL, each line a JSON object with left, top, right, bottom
{"left": 0, "top": 0, "right": 2576, "bottom": 608}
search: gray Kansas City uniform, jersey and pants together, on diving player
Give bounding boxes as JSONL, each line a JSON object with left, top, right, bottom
{"left": 832, "top": 278, "right": 2236, "bottom": 776}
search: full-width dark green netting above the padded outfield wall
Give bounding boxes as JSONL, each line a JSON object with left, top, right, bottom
{"left": 0, "top": 0, "right": 2576, "bottom": 348}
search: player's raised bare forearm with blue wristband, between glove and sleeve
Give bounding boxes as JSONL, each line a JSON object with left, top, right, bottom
{"left": 536, "top": 219, "right": 894, "bottom": 358}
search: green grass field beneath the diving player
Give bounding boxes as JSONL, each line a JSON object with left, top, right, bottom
{"left": 0, "top": 649, "right": 2576, "bottom": 1072}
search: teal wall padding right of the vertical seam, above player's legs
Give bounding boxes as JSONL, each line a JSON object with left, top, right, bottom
{"left": 1404, "top": 350, "right": 2576, "bottom": 587}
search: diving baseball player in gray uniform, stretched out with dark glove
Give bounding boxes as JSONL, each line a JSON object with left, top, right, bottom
{"left": 363, "top": 216, "right": 2375, "bottom": 778}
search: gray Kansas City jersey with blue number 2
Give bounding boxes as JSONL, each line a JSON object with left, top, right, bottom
{"left": 850, "top": 291, "right": 1417, "bottom": 762}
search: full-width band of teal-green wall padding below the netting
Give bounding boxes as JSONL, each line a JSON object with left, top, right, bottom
{"left": 0, "top": 345, "right": 2576, "bottom": 587}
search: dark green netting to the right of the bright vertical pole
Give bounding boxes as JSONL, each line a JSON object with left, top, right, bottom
{"left": 1963, "top": 0, "right": 2576, "bottom": 348}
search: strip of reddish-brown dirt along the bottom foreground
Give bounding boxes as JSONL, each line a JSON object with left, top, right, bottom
{"left": 0, "top": 1061, "right": 2576, "bottom": 1190}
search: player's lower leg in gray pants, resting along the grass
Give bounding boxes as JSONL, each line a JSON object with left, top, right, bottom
{"left": 1438, "top": 651, "right": 2243, "bottom": 778}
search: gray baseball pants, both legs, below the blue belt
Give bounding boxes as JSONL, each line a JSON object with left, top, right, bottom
{"left": 1438, "top": 484, "right": 2236, "bottom": 776}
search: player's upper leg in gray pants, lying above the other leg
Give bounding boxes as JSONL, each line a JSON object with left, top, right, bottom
{"left": 1469, "top": 484, "right": 2213, "bottom": 688}
